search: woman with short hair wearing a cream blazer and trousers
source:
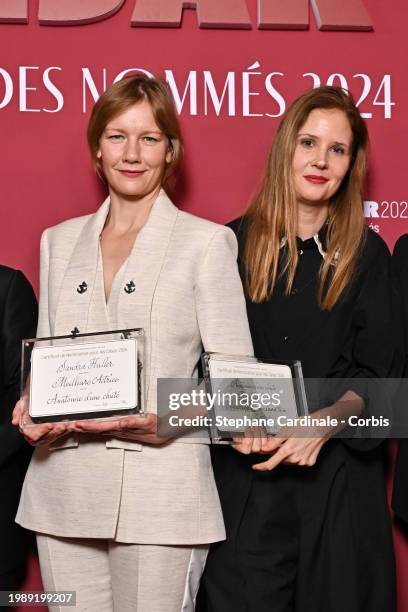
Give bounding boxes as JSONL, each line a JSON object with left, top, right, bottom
{"left": 14, "top": 76, "right": 252, "bottom": 612}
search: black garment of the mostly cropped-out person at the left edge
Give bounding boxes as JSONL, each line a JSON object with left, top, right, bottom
{"left": 0, "top": 266, "right": 38, "bottom": 574}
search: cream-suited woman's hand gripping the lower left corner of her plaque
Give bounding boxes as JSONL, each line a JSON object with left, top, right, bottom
{"left": 11, "top": 397, "right": 72, "bottom": 446}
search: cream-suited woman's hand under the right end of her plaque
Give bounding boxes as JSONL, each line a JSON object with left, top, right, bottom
{"left": 71, "top": 412, "right": 170, "bottom": 445}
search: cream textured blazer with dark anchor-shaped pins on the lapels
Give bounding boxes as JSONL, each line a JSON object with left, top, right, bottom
{"left": 16, "top": 191, "right": 252, "bottom": 545}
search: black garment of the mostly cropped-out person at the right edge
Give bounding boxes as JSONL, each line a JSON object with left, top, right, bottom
{"left": 392, "top": 234, "right": 408, "bottom": 523}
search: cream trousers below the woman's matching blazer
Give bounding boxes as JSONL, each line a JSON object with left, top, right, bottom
{"left": 37, "top": 534, "right": 208, "bottom": 612}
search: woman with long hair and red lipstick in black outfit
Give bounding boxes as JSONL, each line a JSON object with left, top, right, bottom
{"left": 199, "top": 87, "right": 395, "bottom": 612}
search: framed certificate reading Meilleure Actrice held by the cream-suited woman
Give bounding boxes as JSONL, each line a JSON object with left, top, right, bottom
{"left": 21, "top": 329, "right": 144, "bottom": 427}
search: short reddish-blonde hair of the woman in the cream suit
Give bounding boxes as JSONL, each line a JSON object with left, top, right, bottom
{"left": 87, "top": 74, "right": 183, "bottom": 189}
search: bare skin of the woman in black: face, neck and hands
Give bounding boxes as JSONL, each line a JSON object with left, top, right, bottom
{"left": 233, "top": 109, "right": 363, "bottom": 471}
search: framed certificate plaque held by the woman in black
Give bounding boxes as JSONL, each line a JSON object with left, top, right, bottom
{"left": 202, "top": 353, "right": 308, "bottom": 444}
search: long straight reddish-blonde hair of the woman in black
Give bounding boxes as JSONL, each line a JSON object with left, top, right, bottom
{"left": 244, "top": 86, "right": 368, "bottom": 310}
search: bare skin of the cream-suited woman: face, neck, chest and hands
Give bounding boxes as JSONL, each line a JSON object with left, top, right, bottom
{"left": 12, "top": 101, "right": 172, "bottom": 446}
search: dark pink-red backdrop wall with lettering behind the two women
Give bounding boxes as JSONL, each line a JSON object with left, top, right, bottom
{"left": 0, "top": 0, "right": 408, "bottom": 610}
